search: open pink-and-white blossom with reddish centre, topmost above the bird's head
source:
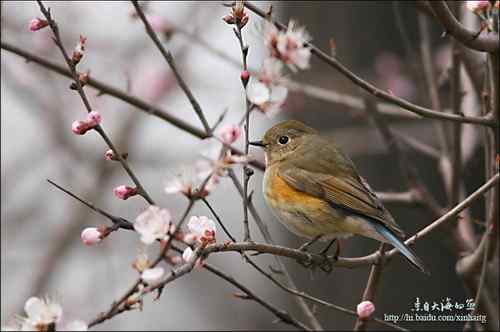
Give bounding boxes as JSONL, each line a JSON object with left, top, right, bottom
{"left": 264, "top": 20, "right": 311, "bottom": 71}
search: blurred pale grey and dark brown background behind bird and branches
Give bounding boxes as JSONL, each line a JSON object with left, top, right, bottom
{"left": 1, "top": 1, "right": 494, "bottom": 330}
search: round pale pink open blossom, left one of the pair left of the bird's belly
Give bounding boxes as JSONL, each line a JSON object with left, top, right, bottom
{"left": 134, "top": 205, "right": 175, "bottom": 244}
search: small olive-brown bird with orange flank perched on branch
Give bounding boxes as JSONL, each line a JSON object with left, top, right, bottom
{"left": 250, "top": 120, "right": 429, "bottom": 274}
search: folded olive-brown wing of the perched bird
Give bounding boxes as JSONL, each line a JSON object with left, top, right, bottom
{"left": 278, "top": 161, "right": 404, "bottom": 237}
